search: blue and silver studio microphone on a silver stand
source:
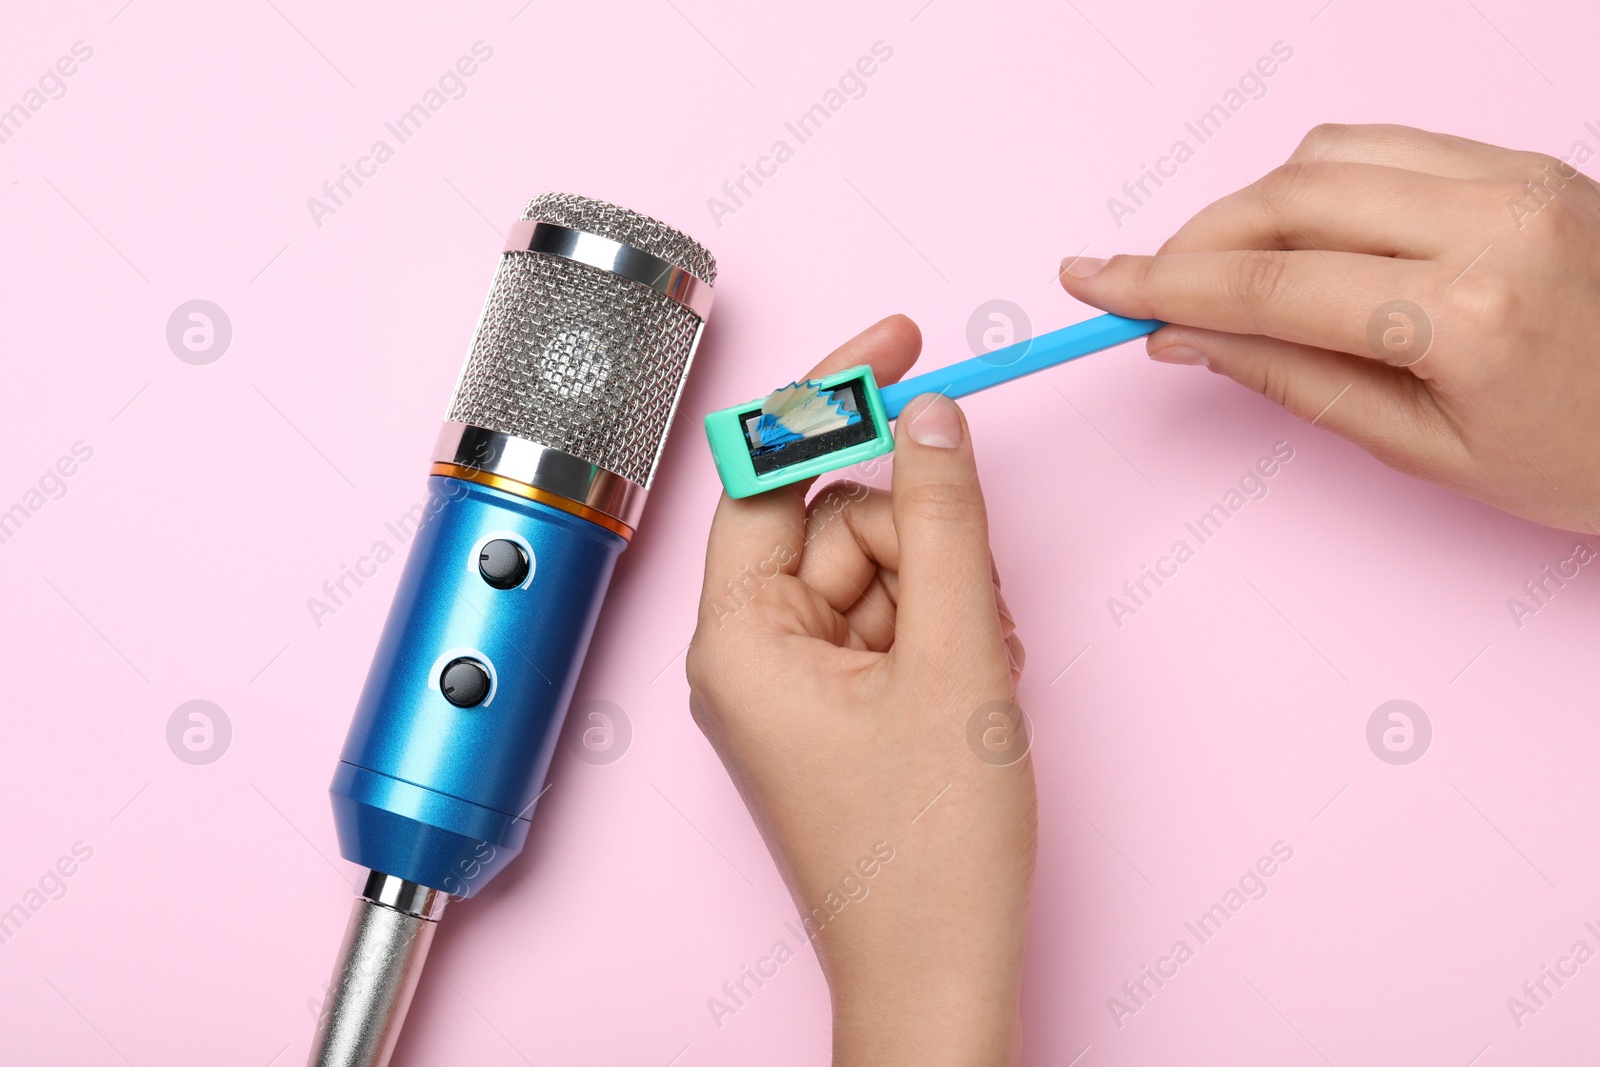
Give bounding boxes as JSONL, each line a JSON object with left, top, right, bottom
{"left": 307, "top": 194, "right": 717, "bottom": 1067}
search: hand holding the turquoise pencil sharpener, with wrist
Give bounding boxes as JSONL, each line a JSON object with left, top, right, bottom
{"left": 688, "top": 317, "right": 1035, "bottom": 1067}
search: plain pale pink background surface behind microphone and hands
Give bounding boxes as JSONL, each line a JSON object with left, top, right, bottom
{"left": 0, "top": 0, "right": 1600, "bottom": 1067}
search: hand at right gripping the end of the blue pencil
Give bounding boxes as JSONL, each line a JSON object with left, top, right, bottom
{"left": 1061, "top": 126, "right": 1600, "bottom": 531}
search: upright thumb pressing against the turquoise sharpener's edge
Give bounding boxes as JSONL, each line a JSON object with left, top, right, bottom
{"left": 891, "top": 394, "right": 1008, "bottom": 680}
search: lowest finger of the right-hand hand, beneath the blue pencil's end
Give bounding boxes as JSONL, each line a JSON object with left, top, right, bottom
{"left": 1147, "top": 326, "right": 1454, "bottom": 474}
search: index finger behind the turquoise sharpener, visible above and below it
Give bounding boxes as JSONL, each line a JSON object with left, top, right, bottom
{"left": 701, "top": 315, "right": 922, "bottom": 627}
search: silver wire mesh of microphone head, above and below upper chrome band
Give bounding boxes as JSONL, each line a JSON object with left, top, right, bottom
{"left": 446, "top": 194, "right": 717, "bottom": 490}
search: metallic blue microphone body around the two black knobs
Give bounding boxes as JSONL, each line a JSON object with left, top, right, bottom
{"left": 330, "top": 477, "right": 627, "bottom": 896}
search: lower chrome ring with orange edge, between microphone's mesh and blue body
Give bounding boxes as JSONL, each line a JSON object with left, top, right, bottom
{"left": 432, "top": 422, "right": 648, "bottom": 537}
